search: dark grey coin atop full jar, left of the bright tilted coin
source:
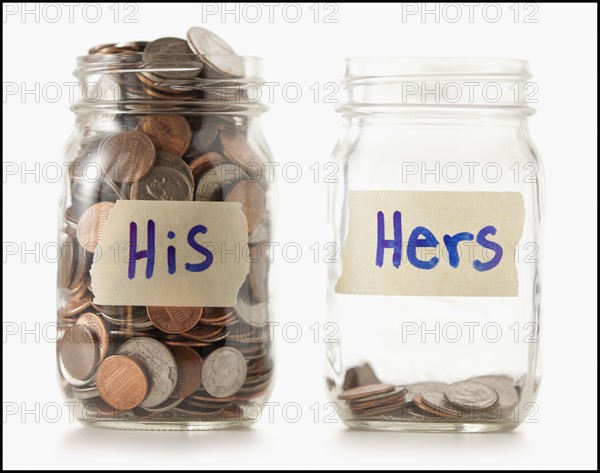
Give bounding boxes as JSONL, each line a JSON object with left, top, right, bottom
{"left": 142, "top": 38, "right": 203, "bottom": 79}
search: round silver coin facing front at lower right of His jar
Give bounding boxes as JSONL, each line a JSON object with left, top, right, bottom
{"left": 202, "top": 347, "right": 247, "bottom": 398}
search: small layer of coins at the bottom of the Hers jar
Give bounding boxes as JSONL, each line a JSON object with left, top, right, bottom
{"left": 338, "top": 365, "right": 519, "bottom": 423}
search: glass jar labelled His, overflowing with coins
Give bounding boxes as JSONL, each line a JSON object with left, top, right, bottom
{"left": 57, "top": 27, "right": 274, "bottom": 429}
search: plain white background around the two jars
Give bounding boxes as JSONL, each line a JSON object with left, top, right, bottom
{"left": 3, "top": 3, "right": 598, "bottom": 470}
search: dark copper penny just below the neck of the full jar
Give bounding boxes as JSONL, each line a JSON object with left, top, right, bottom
{"left": 139, "top": 115, "right": 192, "bottom": 156}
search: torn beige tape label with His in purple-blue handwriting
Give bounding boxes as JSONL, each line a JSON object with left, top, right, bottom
{"left": 91, "top": 200, "right": 250, "bottom": 307}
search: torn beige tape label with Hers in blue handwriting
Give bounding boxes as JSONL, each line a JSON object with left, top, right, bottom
{"left": 336, "top": 191, "right": 525, "bottom": 296}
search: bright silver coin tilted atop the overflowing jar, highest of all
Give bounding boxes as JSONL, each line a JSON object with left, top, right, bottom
{"left": 187, "top": 26, "right": 245, "bottom": 78}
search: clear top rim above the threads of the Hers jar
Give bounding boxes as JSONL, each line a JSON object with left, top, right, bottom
{"left": 344, "top": 56, "right": 530, "bottom": 82}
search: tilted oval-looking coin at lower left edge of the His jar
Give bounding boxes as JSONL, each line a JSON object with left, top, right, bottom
{"left": 58, "top": 325, "right": 100, "bottom": 380}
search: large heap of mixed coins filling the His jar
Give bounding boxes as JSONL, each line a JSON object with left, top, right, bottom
{"left": 57, "top": 28, "right": 273, "bottom": 422}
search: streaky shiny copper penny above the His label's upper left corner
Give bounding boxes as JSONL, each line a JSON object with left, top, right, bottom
{"left": 98, "top": 131, "right": 156, "bottom": 182}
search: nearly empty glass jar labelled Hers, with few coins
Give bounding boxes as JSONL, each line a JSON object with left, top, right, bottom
{"left": 327, "top": 58, "right": 543, "bottom": 432}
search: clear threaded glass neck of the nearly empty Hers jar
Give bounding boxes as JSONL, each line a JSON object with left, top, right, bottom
{"left": 338, "top": 57, "right": 537, "bottom": 117}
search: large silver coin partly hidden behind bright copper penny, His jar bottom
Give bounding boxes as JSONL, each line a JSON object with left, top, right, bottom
{"left": 117, "top": 337, "right": 177, "bottom": 407}
